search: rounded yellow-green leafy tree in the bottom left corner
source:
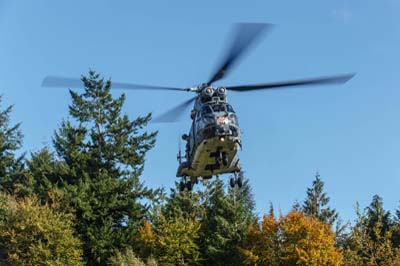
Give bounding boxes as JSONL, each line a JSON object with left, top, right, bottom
{"left": 0, "top": 194, "right": 83, "bottom": 266}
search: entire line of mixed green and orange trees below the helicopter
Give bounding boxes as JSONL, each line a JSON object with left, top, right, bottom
{"left": 0, "top": 71, "right": 400, "bottom": 265}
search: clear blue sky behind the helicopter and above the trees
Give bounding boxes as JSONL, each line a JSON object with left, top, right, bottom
{"left": 0, "top": 0, "right": 400, "bottom": 220}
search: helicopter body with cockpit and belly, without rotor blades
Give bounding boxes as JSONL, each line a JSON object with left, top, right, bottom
{"left": 177, "top": 87, "right": 241, "bottom": 181}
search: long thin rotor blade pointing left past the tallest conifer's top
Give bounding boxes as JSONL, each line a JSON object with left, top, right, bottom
{"left": 42, "top": 76, "right": 187, "bottom": 91}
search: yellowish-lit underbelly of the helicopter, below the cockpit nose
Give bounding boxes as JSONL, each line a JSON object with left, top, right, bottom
{"left": 177, "top": 136, "right": 240, "bottom": 177}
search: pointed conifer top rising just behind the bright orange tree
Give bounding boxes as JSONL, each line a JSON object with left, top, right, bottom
{"left": 301, "top": 173, "right": 338, "bottom": 225}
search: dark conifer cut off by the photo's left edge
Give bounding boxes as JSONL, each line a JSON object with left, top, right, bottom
{"left": 0, "top": 96, "right": 24, "bottom": 193}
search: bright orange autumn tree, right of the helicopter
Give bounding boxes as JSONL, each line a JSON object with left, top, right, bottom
{"left": 241, "top": 211, "right": 343, "bottom": 265}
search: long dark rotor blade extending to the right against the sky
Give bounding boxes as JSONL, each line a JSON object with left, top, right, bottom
{"left": 226, "top": 73, "right": 355, "bottom": 91}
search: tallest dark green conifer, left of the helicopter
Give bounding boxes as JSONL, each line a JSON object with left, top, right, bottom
{"left": 49, "top": 71, "right": 156, "bottom": 265}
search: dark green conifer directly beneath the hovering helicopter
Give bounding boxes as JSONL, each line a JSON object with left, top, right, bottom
{"left": 203, "top": 178, "right": 255, "bottom": 265}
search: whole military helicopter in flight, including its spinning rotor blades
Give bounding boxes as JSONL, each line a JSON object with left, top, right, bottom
{"left": 42, "top": 23, "right": 355, "bottom": 190}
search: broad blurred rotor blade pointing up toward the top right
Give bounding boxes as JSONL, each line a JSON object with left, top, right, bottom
{"left": 207, "top": 23, "right": 273, "bottom": 85}
